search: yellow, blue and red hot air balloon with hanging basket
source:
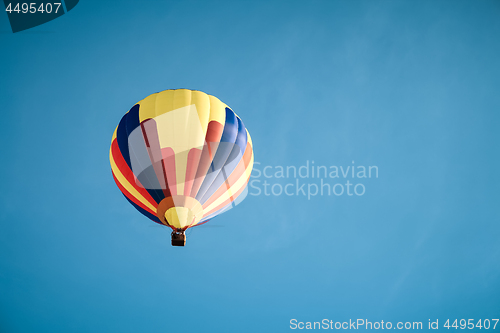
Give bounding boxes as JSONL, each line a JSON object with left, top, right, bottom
{"left": 110, "top": 89, "right": 253, "bottom": 246}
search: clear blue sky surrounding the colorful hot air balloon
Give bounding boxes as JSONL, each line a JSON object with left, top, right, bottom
{"left": 0, "top": 0, "right": 500, "bottom": 333}
